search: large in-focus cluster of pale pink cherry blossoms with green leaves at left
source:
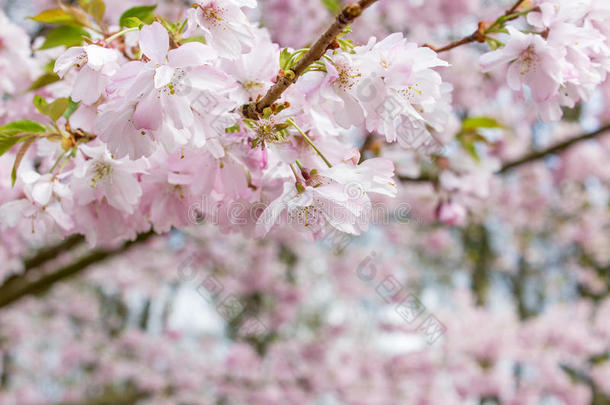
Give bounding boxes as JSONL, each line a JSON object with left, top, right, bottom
{"left": 0, "top": 0, "right": 460, "bottom": 244}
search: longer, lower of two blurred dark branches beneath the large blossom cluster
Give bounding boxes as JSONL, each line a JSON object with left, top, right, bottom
{"left": 0, "top": 231, "right": 155, "bottom": 308}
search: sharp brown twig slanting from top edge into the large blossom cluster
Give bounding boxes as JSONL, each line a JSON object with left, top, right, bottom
{"left": 242, "top": 0, "right": 377, "bottom": 120}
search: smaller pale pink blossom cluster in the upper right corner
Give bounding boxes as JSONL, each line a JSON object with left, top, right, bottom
{"left": 481, "top": 0, "right": 610, "bottom": 121}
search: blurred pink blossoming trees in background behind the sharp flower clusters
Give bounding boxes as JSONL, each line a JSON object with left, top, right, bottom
{"left": 0, "top": 0, "right": 610, "bottom": 405}
